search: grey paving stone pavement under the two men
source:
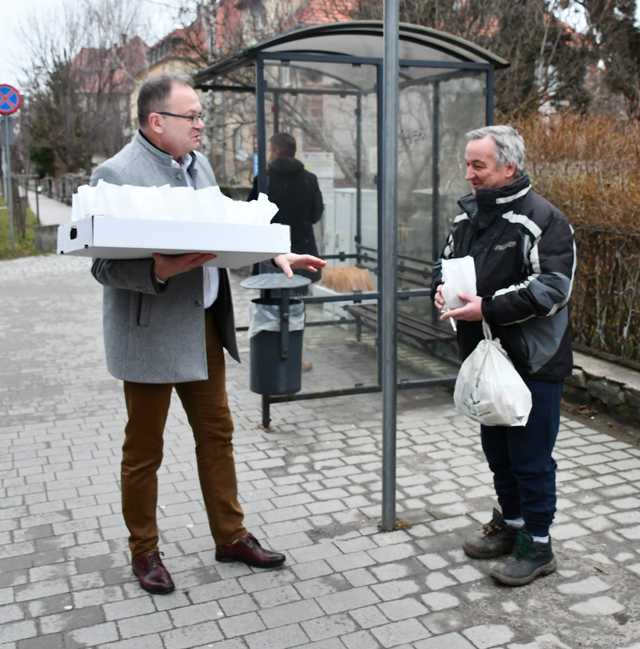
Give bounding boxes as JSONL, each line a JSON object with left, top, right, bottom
{"left": 0, "top": 256, "right": 640, "bottom": 649}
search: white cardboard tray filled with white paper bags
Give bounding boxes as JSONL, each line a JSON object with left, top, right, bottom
{"left": 57, "top": 181, "right": 291, "bottom": 268}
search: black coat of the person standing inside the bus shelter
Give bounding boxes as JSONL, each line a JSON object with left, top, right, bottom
{"left": 249, "top": 158, "right": 324, "bottom": 281}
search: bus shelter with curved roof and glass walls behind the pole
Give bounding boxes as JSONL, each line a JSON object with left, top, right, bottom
{"left": 195, "top": 21, "right": 508, "bottom": 427}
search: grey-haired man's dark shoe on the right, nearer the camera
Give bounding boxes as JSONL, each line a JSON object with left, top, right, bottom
{"left": 489, "top": 530, "right": 556, "bottom": 586}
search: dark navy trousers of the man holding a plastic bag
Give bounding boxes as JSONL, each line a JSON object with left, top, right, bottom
{"left": 481, "top": 381, "right": 562, "bottom": 536}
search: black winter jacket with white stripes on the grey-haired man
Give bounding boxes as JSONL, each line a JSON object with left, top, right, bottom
{"left": 432, "top": 176, "right": 576, "bottom": 382}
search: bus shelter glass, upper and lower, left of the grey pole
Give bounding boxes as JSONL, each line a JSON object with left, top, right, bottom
{"left": 258, "top": 62, "right": 378, "bottom": 391}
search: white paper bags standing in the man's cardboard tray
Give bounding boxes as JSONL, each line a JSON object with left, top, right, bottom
{"left": 71, "top": 180, "right": 278, "bottom": 225}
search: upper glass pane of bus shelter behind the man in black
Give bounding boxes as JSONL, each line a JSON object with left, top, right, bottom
{"left": 265, "top": 63, "right": 378, "bottom": 266}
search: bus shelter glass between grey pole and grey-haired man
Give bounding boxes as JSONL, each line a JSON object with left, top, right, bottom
{"left": 398, "top": 70, "right": 486, "bottom": 378}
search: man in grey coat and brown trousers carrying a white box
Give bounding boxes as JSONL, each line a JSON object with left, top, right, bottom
{"left": 91, "top": 76, "right": 324, "bottom": 594}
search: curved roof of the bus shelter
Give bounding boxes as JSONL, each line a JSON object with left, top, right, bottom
{"left": 195, "top": 20, "right": 509, "bottom": 87}
